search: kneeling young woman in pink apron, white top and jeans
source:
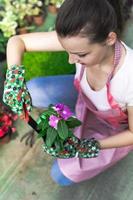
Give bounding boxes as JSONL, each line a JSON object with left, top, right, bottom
{"left": 3, "top": 0, "right": 133, "bottom": 185}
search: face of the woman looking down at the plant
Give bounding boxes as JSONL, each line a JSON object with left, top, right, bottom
{"left": 58, "top": 36, "right": 112, "bottom": 67}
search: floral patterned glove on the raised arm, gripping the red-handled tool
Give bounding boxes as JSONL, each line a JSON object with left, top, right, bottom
{"left": 3, "top": 65, "right": 32, "bottom": 116}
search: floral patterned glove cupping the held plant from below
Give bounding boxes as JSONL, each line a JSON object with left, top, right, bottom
{"left": 43, "top": 136, "right": 100, "bottom": 159}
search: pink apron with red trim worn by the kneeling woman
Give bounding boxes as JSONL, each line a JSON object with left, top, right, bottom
{"left": 58, "top": 43, "right": 133, "bottom": 182}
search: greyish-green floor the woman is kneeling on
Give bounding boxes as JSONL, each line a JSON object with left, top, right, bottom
{"left": 0, "top": 18, "right": 133, "bottom": 200}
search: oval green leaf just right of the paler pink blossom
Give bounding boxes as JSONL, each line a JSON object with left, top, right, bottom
{"left": 57, "top": 120, "right": 68, "bottom": 140}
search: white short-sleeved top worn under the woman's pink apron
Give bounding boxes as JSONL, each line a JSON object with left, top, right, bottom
{"left": 75, "top": 43, "right": 133, "bottom": 111}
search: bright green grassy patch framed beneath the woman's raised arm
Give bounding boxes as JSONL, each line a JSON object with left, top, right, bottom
{"left": 23, "top": 52, "right": 75, "bottom": 80}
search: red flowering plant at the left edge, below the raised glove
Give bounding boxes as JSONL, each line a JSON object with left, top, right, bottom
{"left": 0, "top": 104, "right": 17, "bottom": 144}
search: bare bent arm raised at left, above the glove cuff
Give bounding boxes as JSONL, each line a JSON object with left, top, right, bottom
{"left": 7, "top": 31, "right": 64, "bottom": 67}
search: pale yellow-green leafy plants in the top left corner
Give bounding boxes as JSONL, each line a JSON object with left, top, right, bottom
{"left": 0, "top": 0, "right": 43, "bottom": 37}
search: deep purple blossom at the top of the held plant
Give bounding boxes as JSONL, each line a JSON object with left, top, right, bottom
{"left": 53, "top": 103, "right": 73, "bottom": 120}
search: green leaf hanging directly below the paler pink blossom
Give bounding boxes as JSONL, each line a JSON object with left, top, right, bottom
{"left": 46, "top": 127, "right": 58, "bottom": 147}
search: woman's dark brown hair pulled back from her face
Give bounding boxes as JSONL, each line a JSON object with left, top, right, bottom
{"left": 55, "top": 0, "right": 123, "bottom": 43}
